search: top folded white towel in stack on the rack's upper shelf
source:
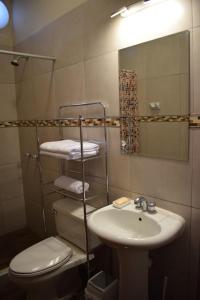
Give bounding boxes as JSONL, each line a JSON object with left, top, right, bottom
{"left": 40, "top": 140, "right": 99, "bottom": 155}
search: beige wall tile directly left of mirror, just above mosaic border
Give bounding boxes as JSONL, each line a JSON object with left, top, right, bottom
{"left": 85, "top": 52, "right": 119, "bottom": 115}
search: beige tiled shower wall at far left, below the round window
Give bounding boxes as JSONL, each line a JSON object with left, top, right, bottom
{"left": 0, "top": 1, "right": 25, "bottom": 235}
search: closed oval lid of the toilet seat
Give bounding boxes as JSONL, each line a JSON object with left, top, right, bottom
{"left": 10, "top": 237, "right": 72, "bottom": 275}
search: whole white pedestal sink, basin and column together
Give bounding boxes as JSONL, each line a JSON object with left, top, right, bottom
{"left": 88, "top": 201, "right": 185, "bottom": 300}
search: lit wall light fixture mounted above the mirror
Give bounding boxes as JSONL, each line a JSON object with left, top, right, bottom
{"left": 110, "top": 0, "right": 164, "bottom": 18}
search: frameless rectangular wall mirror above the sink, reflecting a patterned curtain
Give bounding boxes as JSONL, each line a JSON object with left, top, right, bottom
{"left": 119, "top": 31, "right": 190, "bottom": 161}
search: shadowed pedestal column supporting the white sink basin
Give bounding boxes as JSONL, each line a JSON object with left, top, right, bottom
{"left": 117, "top": 247, "right": 149, "bottom": 300}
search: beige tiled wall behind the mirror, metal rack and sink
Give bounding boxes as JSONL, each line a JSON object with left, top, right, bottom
{"left": 12, "top": 0, "right": 200, "bottom": 300}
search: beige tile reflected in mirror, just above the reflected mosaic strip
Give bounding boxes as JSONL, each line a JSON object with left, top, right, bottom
{"left": 137, "top": 74, "right": 189, "bottom": 116}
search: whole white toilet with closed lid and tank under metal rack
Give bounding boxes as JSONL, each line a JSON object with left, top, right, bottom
{"left": 9, "top": 198, "right": 98, "bottom": 300}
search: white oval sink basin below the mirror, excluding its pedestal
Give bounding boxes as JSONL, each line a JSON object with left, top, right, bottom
{"left": 88, "top": 201, "right": 185, "bottom": 249}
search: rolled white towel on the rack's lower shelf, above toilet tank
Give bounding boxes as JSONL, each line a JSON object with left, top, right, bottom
{"left": 54, "top": 176, "right": 89, "bottom": 194}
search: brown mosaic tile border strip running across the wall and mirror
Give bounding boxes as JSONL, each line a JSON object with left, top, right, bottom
{"left": 0, "top": 115, "right": 200, "bottom": 128}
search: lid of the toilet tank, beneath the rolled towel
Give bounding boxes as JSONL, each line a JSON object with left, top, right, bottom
{"left": 53, "top": 198, "right": 95, "bottom": 220}
